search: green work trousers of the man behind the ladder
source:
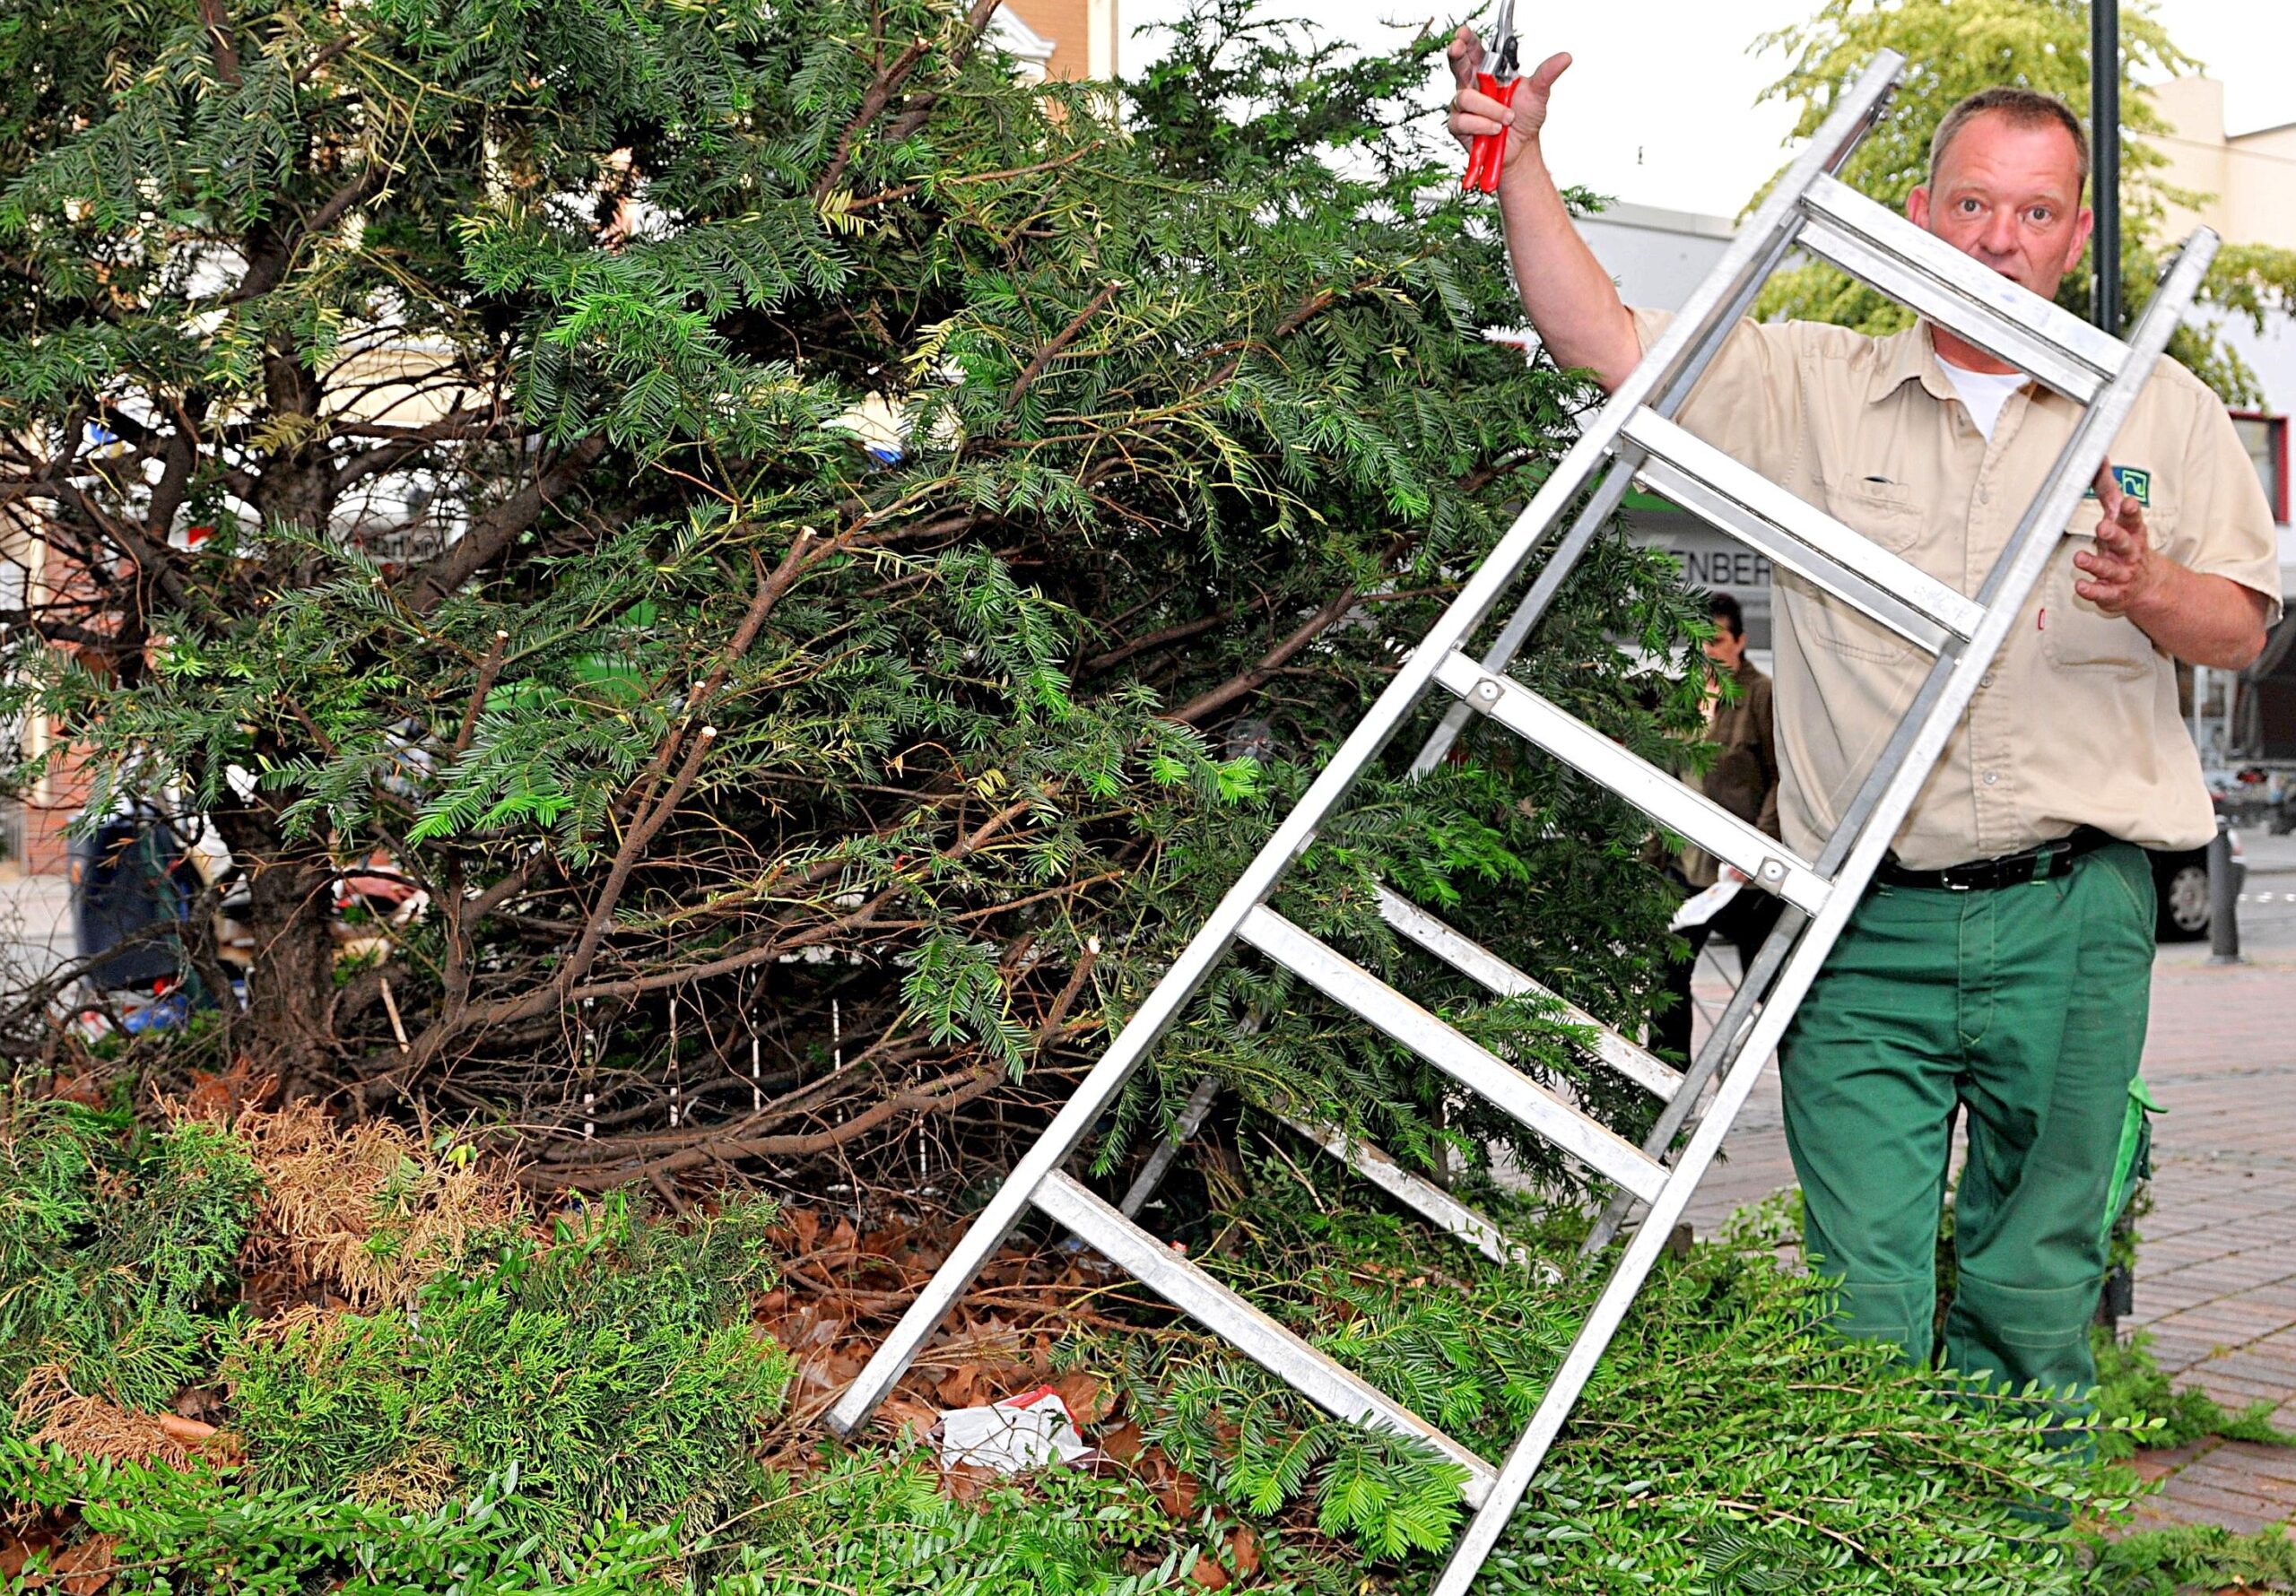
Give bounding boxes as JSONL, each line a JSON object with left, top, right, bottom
{"left": 1779, "top": 843, "right": 2153, "bottom": 1392}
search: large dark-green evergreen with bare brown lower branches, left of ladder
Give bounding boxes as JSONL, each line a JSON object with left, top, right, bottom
{"left": 0, "top": 0, "right": 1697, "bottom": 1187}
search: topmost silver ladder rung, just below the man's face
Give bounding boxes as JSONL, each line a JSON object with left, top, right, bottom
{"left": 1797, "top": 177, "right": 2128, "bottom": 404}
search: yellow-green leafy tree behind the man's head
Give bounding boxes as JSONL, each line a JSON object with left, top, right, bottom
{"left": 1756, "top": 0, "right": 2296, "bottom": 404}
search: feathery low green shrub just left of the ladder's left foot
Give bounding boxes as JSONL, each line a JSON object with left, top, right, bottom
{"left": 221, "top": 1196, "right": 790, "bottom": 1536}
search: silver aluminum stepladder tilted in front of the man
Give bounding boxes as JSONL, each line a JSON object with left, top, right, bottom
{"left": 827, "top": 50, "right": 2215, "bottom": 1596}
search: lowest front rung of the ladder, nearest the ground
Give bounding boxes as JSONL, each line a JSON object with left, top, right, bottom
{"left": 1031, "top": 1169, "right": 1497, "bottom": 1506}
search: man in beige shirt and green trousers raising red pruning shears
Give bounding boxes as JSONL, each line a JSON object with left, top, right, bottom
{"left": 1451, "top": 40, "right": 2280, "bottom": 1392}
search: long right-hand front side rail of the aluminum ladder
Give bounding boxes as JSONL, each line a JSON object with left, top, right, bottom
{"left": 1432, "top": 228, "right": 2215, "bottom": 1596}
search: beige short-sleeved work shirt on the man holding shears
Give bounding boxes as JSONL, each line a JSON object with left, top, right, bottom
{"left": 1632, "top": 310, "right": 2280, "bottom": 871}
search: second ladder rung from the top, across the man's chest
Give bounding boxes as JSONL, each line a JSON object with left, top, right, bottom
{"left": 1625, "top": 409, "right": 1986, "bottom": 655}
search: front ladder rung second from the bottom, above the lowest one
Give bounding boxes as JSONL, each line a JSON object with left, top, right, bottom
{"left": 1235, "top": 905, "right": 1667, "bottom": 1201}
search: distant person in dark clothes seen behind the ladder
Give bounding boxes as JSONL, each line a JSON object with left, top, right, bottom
{"left": 1651, "top": 593, "right": 1784, "bottom": 1059}
